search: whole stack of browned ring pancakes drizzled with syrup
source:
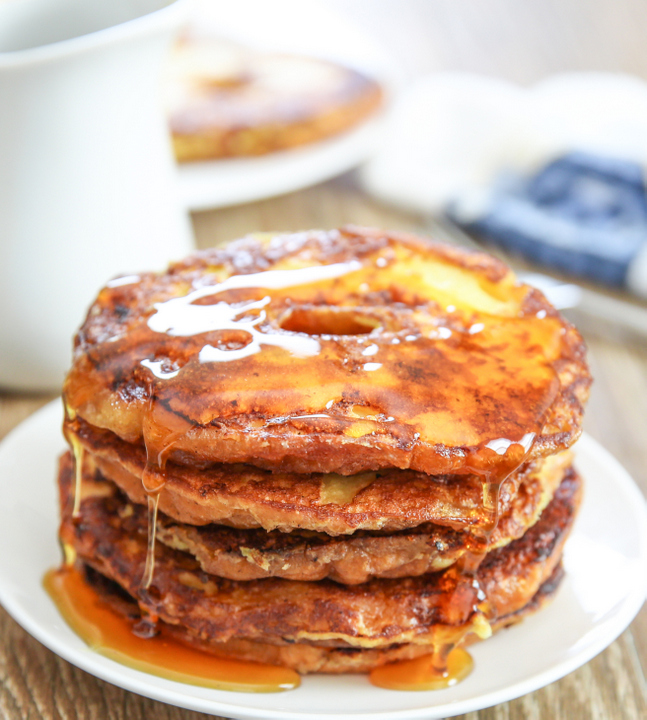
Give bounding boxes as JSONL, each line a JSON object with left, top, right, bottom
{"left": 59, "top": 227, "right": 590, "bottom": 673}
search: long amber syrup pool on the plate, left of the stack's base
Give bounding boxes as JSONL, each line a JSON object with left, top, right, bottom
{"left": 43, "top": 566, "right": 301, "bottom": 692}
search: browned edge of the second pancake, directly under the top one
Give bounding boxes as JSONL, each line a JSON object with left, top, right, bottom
{"left": 68, "top": 425, "right": 569, "bottom": 535}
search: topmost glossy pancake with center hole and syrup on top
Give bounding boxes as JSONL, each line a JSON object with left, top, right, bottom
{"left": 64, "top": 227, "right": 590, "bottom": 475}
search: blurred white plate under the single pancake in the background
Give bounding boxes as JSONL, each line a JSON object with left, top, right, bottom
{"left": 172, "top": 0, "right": 398, "bottom": 210}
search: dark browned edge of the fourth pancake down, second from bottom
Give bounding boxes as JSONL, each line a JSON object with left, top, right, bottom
{"left": 61, "top": 458, "right": 581, "bottom": 648}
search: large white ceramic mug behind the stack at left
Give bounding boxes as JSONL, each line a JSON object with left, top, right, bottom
{"left": 0, "top": 0, "right": 193, "bottom": 390}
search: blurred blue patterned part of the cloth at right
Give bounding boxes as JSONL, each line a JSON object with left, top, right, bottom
{"left": 447, "top": 152, "right": 647, "bottom": 287}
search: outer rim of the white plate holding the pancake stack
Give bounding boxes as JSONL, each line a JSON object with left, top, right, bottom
{"left": 0, "top": 398, "right": 647, "bottom": 720}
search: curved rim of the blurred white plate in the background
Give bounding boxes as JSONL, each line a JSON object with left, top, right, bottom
{"left": 176, "top": 0, "right": 394, "bottom": 212}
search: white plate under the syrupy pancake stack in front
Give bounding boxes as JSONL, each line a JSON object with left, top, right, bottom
{"left": 0, "top": 403, "right": 647, "bottom": 720}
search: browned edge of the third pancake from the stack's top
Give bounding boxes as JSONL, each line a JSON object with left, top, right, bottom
{"left": 59, "top": 453, "right": 569, "bottom": 584}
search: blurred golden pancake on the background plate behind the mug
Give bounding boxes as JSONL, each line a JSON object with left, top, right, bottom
{"left": 166, "top": 33, "right": 382, "bottom": 162}
